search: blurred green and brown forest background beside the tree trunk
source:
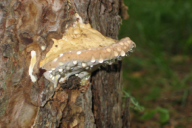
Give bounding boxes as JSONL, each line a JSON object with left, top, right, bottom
{"left": 119, "top": 0, "right": 192, "bottom": 128}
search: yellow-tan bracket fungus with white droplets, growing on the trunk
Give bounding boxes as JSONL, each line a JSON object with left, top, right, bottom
{"left": 29, "top": 14, "right": 136, "bottom": 88}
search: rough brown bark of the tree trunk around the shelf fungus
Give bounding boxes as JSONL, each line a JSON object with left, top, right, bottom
{"left": 0, "top": 0, "right": 129, "bottom": 128}
